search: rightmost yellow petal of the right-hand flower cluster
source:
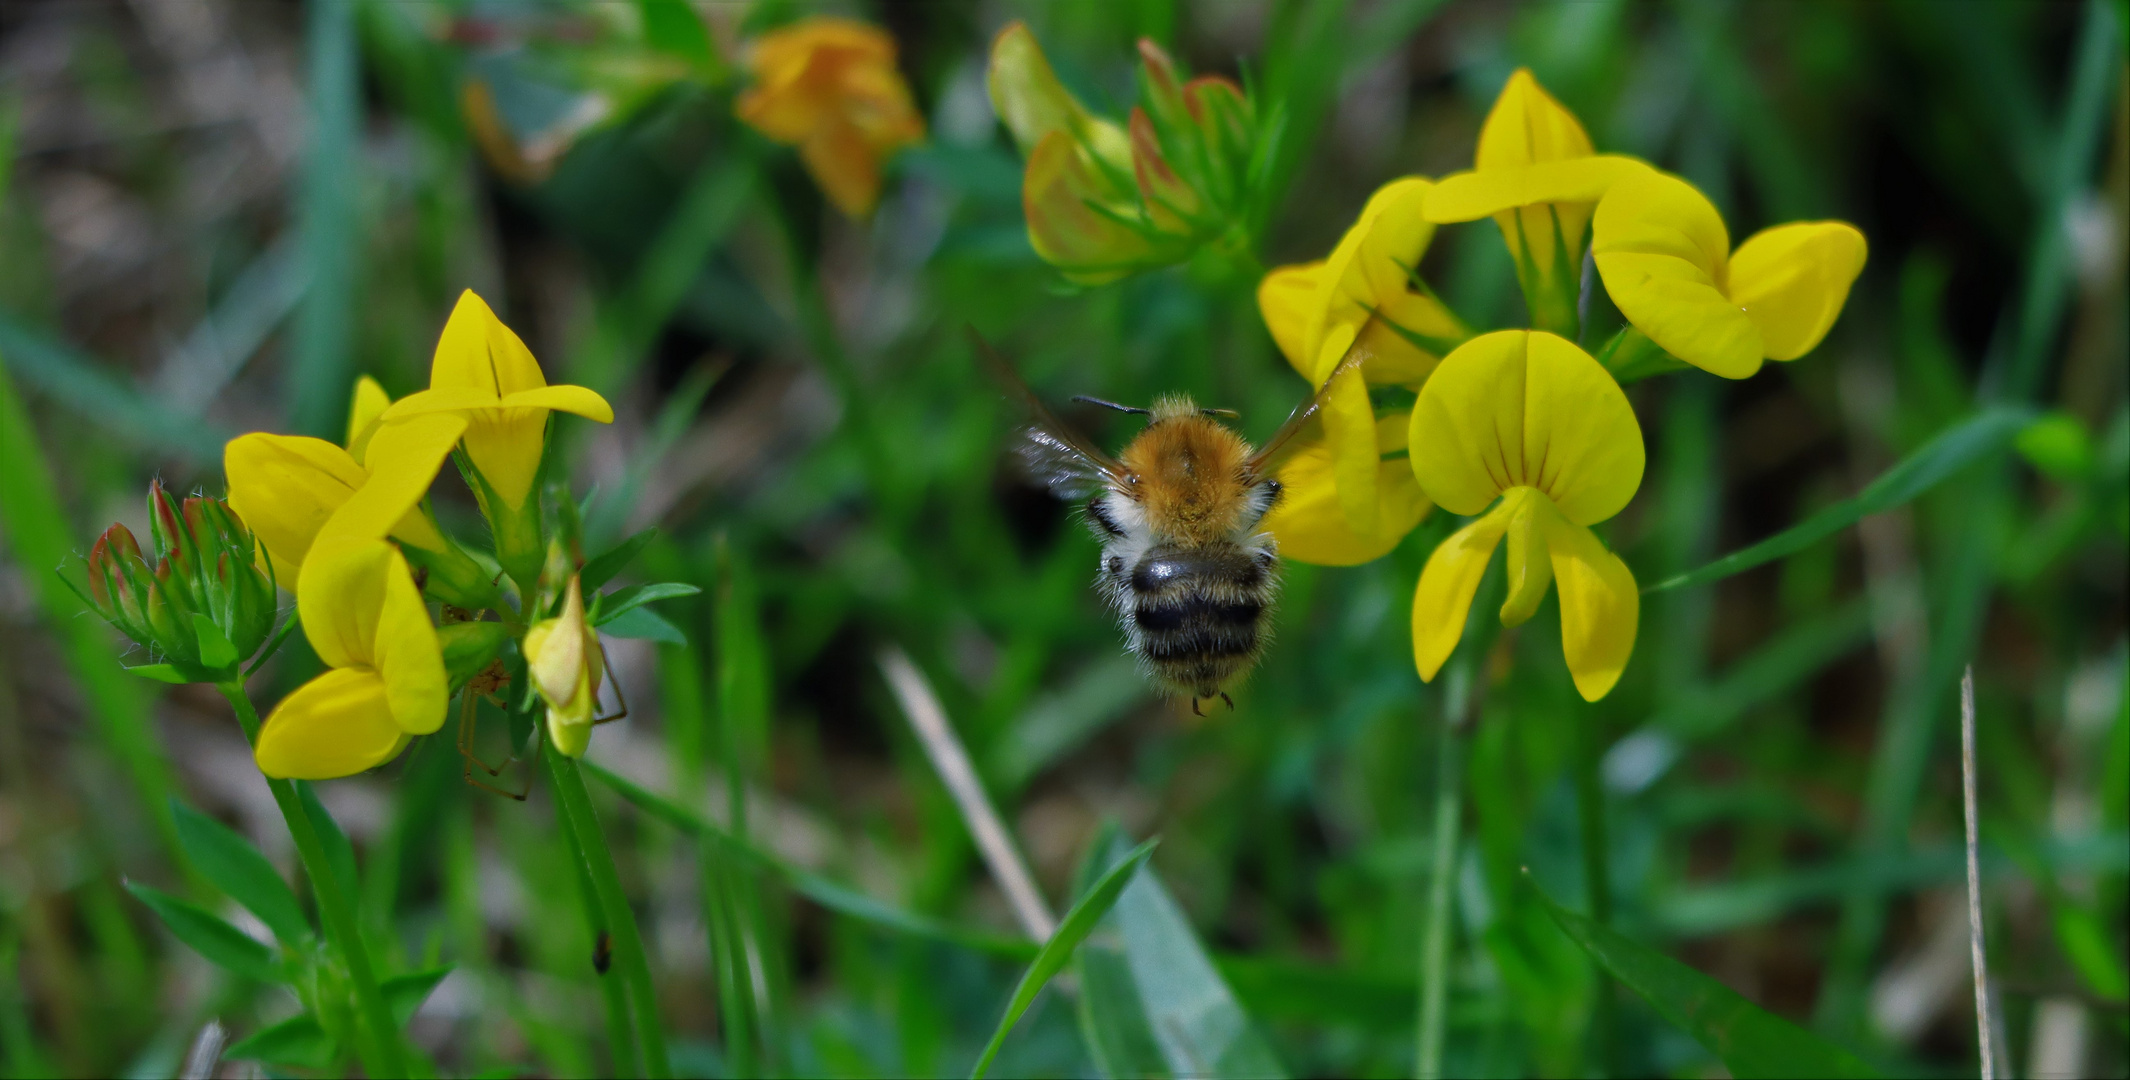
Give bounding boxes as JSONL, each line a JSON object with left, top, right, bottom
{"left": 1730, "top": 222, "right": 1866, "bottom": 360}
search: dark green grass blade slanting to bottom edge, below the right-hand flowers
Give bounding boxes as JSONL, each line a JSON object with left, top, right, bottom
{"left": 1525, "top": 871, "right": 1879, "bottom": 1080}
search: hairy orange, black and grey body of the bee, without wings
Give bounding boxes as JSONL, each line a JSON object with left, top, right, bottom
{"left": 1086, "top": 398, "right": 1280, "bottom": 701}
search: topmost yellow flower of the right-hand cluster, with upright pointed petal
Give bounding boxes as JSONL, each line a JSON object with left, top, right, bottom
{"left": 1427, "top": 68, "right": 1649, "bottom": 330}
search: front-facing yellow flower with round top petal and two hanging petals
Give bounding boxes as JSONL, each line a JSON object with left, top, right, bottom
{"left": 1412, "top": 330, "right": 1644, "bottom": 701}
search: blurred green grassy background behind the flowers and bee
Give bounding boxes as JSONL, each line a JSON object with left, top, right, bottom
{"left": 0, "top": 0, "right": 2130, "bottom": 1076}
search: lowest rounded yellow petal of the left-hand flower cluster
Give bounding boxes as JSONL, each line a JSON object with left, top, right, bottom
{"left": 251, "top": 667, "right": 407, "bottom": 780}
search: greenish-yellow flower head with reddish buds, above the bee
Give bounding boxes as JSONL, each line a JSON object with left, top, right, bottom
{"left": 988, "top": 21, "right": 1263, "bottom": 285}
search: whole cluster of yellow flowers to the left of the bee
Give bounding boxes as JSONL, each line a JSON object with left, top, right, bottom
{"left": 224, "top": 292, "right": 613, "bottom": 780}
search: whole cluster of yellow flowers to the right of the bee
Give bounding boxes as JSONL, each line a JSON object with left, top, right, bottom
{"left": 1257, "top": 70, "right": 1866, "bottom": 701}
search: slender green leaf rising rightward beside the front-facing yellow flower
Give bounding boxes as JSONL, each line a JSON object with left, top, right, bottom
{"left": 1642, "top": 405, "right": 2034, "bottom": 594}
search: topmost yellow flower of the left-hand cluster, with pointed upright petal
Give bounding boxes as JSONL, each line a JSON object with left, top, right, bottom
{"left": 381, "top": 290, "right": 613, "bottom": 513}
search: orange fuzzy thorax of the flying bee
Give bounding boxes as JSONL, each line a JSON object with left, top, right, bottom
{"left": 1123, "top": 396, "right": 1250, "bottom": 543}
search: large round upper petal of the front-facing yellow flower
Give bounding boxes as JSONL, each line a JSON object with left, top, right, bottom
{"left": 1410, "top": 330, "right": 1644, "bottom": 524}
